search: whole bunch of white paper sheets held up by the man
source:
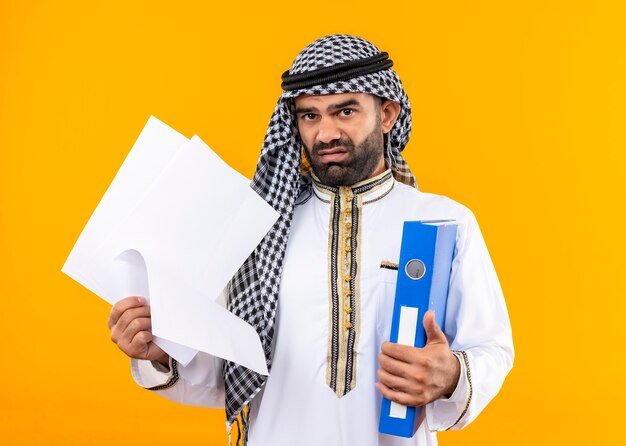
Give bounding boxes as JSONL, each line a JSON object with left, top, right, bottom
{"left": 63, "top": 117, "right": 278, "bottom": 374}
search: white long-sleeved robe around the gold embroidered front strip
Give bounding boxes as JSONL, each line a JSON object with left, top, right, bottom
{"left": 132, "top": 172, "right": 513, "bottom": 446}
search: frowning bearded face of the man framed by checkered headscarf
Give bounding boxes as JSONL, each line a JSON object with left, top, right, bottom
{"left": 295, "top": 93, "right": 385, "bottom": 186}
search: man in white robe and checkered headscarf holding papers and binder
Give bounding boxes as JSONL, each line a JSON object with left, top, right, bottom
{"left": 109, "top": 35, "right": 513, "bottom": 446}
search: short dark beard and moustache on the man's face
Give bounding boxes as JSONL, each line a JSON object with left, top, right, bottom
{"left": 303, "top": 122, "right": 384, "bottom": 187}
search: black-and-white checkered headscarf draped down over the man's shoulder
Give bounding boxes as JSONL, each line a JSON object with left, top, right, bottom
{"left": 224, "top": 34, "right": 415, "bottom": 436}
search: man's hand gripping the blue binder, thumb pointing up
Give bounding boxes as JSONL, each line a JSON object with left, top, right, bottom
{"left": 376, "top": 311, "right": 461, "bottom": 407}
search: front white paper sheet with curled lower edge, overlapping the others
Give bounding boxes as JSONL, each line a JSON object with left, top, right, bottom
{"left": 92, "top": 136, "right": 278, "bottom": 374}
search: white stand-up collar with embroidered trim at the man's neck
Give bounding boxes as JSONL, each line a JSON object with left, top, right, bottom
{"left": 311, "top": 169, "right": 395, "bottom": 204}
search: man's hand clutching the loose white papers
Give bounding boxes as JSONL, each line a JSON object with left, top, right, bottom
{"left": 109, "top": 296, "right": 169, "bottom": 365}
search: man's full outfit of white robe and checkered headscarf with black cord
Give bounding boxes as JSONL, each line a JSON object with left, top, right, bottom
{"left": 128, "top": 35, "right": 513, "bottom": 446}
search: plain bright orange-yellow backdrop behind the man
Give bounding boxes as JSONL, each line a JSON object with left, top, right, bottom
{"left": 0, "top": 0, "right": 626, "bottom": 446}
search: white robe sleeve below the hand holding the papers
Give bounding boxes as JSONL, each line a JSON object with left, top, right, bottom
{"left": 131, "top": 352, "right": 224, "bottom": 408}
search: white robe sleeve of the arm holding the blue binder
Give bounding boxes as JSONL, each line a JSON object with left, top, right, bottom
{"left": 426, "top": 210, "right": 514, "bottom": 431}
